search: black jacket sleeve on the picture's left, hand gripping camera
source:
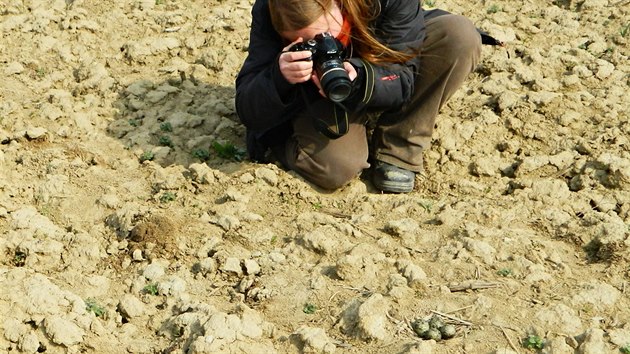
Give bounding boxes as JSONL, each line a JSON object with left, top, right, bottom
{"left": 235, "top": 0, "right": 298, "bottom": 131}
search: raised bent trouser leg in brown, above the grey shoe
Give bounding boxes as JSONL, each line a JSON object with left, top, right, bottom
{"left": 372, "top": 15, "right": 481, "bottom": 172}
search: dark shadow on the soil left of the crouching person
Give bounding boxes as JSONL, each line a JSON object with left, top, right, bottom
{"left": 107, "top": 74, "right": 246, "bottom": 173}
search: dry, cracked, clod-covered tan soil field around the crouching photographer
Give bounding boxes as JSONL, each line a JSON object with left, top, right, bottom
{"left": 0, "top": 0, "right": 630, "bottom": 354}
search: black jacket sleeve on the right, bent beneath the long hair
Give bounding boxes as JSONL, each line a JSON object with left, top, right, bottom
{"left": 351, "top": 0, "right": 426, "bottom": 110}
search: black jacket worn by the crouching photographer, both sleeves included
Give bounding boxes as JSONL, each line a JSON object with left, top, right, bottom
{"left": 236, "top": 0, "right": 498, "bottom": 159}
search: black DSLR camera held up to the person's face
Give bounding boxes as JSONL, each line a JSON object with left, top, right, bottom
{"left": 289, "top": 32, "right": 352, "bottom": 102}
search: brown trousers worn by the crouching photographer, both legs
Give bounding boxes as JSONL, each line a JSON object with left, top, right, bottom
{"left": 274, "top": 14, "right": 481, "bottom": 190}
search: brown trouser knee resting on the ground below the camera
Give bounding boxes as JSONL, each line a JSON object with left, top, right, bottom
{"left": 284, "top": 99, "right": 370, "bottom": 190}
